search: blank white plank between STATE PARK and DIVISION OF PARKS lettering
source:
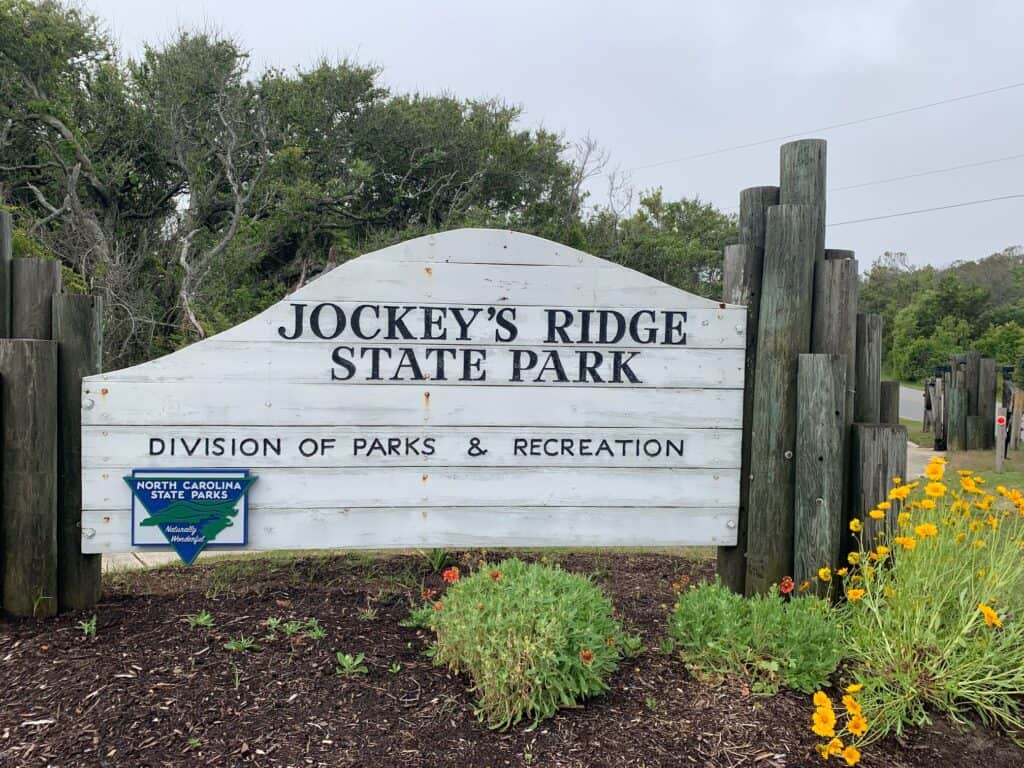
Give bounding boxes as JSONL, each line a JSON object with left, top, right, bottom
{"left": 82, "top": 379, "right": 743, "bottom": 428}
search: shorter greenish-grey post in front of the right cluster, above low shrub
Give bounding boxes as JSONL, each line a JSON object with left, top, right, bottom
{"left": 793, "top": 354, "right": 848, "bottom": 582}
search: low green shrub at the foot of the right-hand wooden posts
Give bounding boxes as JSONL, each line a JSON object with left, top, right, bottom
{"left": 669, "top": 584, "right": 840, "bottom": 693}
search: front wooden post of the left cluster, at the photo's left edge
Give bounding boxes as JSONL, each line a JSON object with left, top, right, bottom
{"left": 0, "top": 339, "right": 57, "bottom": 616}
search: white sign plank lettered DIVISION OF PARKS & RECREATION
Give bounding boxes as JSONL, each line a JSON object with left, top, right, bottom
{"left": 82, "top": 425, "right": 740, "bottom": 469}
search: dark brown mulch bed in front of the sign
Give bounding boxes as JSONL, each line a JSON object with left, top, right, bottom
{"left": 0, "top": 553, "right": 1024, "bottom": 768}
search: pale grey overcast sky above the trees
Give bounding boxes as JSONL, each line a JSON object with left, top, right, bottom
{"left": 86, "top": 0, "right": 1024, "bottom": 268}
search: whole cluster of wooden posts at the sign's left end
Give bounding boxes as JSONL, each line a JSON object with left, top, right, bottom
{"left": 0, "top": 211, "right": 102, "bottom": 616}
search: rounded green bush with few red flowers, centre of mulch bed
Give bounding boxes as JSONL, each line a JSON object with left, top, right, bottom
{"left": 414, "top": 559, "right": 639, "bottom": 728}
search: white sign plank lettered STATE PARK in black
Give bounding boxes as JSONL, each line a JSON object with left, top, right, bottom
{"left": 86, "top": 341, "right": 744, "bottom": 396}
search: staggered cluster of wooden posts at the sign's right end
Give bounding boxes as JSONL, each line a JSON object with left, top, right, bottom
{"left": 718, "top": 139, "right": 907, "bottom": 594}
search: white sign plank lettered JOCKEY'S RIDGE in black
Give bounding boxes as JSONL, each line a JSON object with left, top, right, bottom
{"left": 216, "top": 303, "right": 746, "bottom": 354}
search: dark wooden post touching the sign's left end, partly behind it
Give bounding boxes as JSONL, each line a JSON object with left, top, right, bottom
{"left": 53, "top": 294, "right": 102, "bottom": 610}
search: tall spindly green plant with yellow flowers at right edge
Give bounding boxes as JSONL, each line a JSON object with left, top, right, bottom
{"left": 838, "top": 459, "right": 1024, "bottom": 743}
